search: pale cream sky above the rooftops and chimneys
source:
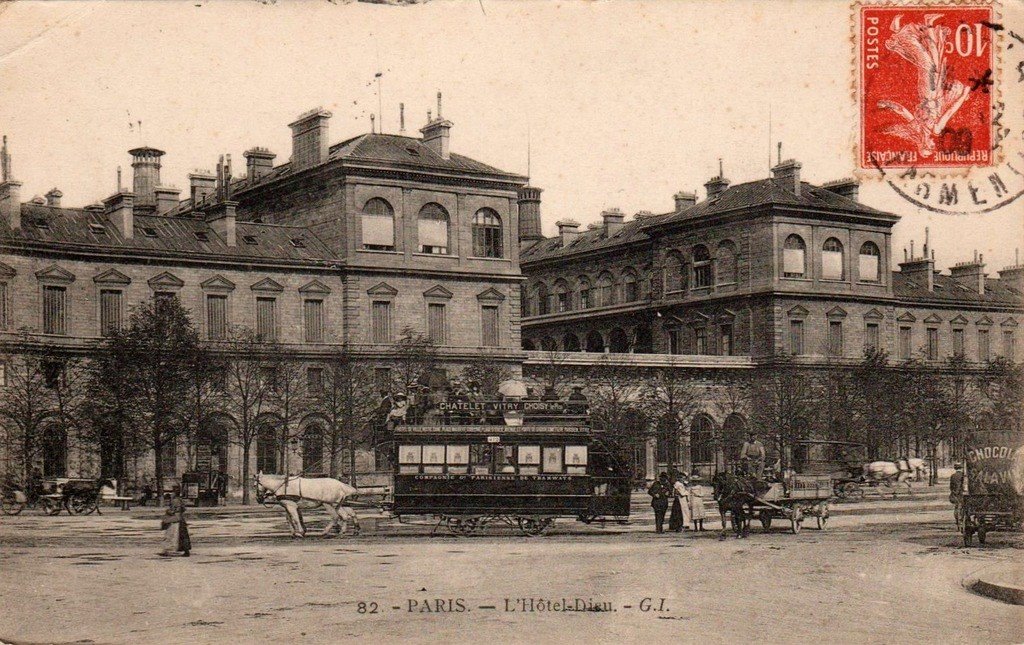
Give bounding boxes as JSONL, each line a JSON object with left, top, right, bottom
{"left": 0, "top": 0, "right": 1024, "bottom": 273}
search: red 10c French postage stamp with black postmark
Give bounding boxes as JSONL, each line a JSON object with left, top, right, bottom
{"left": 857, "top": 2, "right": 997, "bottom": 169}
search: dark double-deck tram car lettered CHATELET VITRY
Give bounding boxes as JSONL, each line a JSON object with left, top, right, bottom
{"left": 390, "top": 401, "right": 630, "bottom": 535}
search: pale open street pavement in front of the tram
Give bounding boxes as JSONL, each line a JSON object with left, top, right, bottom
{"left": 0, "top": 493, "right": 1024, "bottom": 643}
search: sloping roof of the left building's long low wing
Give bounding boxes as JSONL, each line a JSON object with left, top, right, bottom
{"left": 0, "top": 203, "right": 337, "bottom": 261}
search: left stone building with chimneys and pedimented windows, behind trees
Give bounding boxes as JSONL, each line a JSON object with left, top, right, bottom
{"left": 0, "top": 104, "right": 529, "bottom": 497}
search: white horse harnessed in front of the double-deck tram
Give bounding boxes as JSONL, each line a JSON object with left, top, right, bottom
{"left": 254, "top": 472, "right": 359, "bottom": 538}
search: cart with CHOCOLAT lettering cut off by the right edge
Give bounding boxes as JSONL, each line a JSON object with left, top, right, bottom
{"left": 963, "top": 430, "right": 1024, "bottom": 547}
